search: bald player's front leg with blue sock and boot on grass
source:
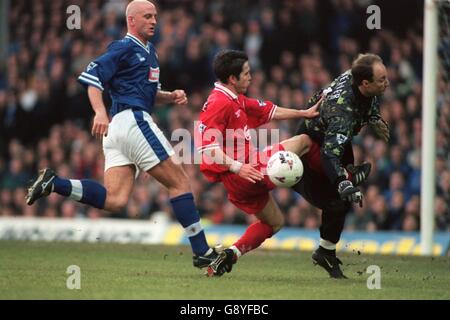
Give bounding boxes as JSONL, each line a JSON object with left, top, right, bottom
{"left": 147, "top": 157, "right": 213, "bottom": 262}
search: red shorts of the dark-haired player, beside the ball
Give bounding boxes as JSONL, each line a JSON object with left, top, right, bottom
{"left": 220, "top": 144, "right": 284, "bottom": 214}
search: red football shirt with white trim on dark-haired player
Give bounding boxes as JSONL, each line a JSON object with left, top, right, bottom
{"left": 195, "top": 83, "right": 277, "bottom": 181}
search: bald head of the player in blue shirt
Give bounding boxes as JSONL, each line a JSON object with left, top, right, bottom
{"left": 125, "top": 0, "right": 157, "bottom": 43}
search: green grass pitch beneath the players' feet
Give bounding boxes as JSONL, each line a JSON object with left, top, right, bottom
{"left": 0, "top": 241, "right": 450, "bottom": 300}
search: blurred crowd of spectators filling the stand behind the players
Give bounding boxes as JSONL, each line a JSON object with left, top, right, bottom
{"left": 0, "top": 0, "right": 450, "bottom": 231}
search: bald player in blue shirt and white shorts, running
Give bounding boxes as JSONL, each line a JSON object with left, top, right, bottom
{"left": 26, "top": 0, "right": 217, "bottom": 268}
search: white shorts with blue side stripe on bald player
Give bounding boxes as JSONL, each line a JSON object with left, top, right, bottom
{"left": 103, "top": 109, "right": 175, "bottom": 177}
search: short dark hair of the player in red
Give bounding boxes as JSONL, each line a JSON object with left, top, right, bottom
{"left": 213, "top": 49, "right": 248, "bottom": 83}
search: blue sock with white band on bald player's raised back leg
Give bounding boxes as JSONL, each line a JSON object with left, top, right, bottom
{"left": 53, "top": 177, "right": 106, "bottom": 209}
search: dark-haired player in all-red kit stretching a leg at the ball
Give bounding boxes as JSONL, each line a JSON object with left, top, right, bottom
{"left": 195, "top": 50, "right": 321, "bottom": 276}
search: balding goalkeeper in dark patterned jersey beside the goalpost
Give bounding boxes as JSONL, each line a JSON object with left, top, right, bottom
{"left": 292, "top": 54, "right": 389, "bottom": 278}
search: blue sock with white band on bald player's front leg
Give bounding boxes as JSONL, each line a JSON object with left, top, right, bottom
{"left": 170, "top": 193, "right": 209, "bottom": 255}
